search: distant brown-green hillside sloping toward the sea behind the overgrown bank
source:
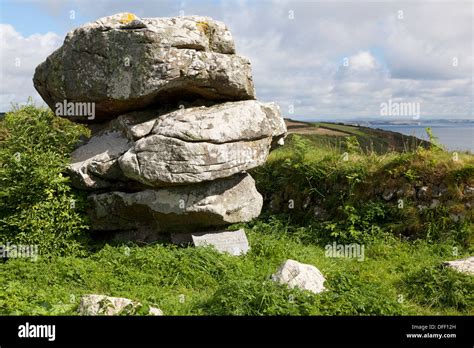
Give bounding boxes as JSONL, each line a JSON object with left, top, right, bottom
{"left": 285, "top": 119, "right": 430, "bottom": 153}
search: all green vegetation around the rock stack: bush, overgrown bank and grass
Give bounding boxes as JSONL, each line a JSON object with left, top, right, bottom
{"left": 0, "top": 106, "right": 474, "bottom": 315}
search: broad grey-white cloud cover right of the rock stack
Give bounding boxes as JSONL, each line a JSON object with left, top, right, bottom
{"left": 217, "top": 1, "right": 474, "bottom": 119}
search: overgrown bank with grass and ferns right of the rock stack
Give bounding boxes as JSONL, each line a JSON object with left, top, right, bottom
{"left": 253, "top": 134, "right": 474, "bottom": 246}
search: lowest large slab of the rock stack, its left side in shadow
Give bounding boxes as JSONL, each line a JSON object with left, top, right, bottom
{"left": 89, "top": 174, "right": 263, "bottom": 240}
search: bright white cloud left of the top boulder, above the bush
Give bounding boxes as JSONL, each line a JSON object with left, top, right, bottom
{"left": 0, "top": 24, "right": 62, "bottom": 111}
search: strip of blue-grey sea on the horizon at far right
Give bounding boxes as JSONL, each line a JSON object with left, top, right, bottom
{"left": 368, "top": 121, "right": 474, "bottom": 153}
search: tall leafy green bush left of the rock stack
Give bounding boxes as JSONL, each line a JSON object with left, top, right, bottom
{"left": 0, "top": 105, "right": 87, "bottom": 256}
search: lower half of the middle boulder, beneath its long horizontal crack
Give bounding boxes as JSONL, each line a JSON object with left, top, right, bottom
{"left": 119, "top": 135, "right": 271, "bottom": 187}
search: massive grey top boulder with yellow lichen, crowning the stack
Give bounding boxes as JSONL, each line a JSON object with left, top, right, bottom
{"left": 33, "top": 14, "right": 255, "bottom": 122}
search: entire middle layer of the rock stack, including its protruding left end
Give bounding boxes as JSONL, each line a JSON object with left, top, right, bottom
{"left": 70, "top": 100, "right": 286, "bottom": 189}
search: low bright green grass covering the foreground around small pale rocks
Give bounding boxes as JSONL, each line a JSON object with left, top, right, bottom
{"left": 0, "top": 217, "right": 474, "bottom": 315}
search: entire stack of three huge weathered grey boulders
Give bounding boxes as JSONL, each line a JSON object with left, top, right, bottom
{"left": 33, "top": 13, "right": 286, "bottom": 241}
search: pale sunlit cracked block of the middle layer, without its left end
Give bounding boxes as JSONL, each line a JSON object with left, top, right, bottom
{"left": 119, "top": 101, "right": 281, "bottom": 187}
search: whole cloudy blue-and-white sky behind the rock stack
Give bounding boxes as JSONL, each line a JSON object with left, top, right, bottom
{"left": 0, "top": 0, "right": 474, "bottom": 120}
